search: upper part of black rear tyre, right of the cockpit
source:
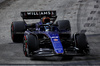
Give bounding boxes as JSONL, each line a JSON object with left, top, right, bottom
{"left": 56, "top": 20, "right": 71, "bottom": 31}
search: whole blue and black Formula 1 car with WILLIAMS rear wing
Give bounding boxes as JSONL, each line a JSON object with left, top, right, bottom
{"left": 11, "top": 11, "right": 89, "bottom": 57}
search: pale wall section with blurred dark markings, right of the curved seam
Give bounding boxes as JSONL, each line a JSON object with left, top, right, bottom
{"left": 77, "top": 0, "right": 100, "bottom": 34}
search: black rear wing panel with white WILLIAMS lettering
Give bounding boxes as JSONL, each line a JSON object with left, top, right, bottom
{"left": 21, "top": 11, "right": 57, "bottom": 19}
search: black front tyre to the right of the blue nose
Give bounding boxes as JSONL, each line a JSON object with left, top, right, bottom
{"left": 75, "top": 34, "right": 89, "bottom": 55}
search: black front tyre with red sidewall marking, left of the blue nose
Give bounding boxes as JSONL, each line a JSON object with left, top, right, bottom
{"left": 23, "top": 35, "right": 39, "bottom": 57}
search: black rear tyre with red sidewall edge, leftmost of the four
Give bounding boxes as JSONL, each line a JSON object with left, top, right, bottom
{"left": 11, "top": 21, "right": 26, "bottom": 42}
